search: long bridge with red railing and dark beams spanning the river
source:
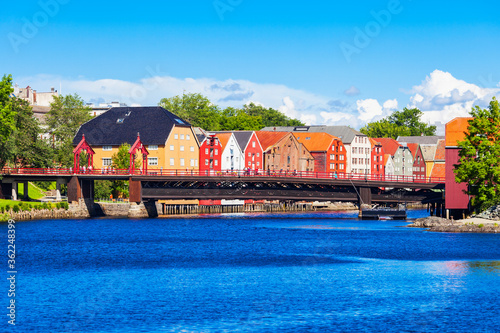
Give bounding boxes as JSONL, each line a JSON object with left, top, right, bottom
{"left": 0, "top": 168, "right": 445, "bottom": 204}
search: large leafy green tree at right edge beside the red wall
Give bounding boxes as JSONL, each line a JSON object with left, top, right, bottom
{"left": 454, "top": 98, "right": 500, "bottom": 211}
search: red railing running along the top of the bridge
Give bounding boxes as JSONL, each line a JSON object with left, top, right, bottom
{"left": 2, "top": 167, "right": 445, "bottom": 184}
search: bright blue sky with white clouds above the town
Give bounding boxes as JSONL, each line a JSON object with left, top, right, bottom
{"left": 0, "top": 0, "right": 500, "bottom": 134}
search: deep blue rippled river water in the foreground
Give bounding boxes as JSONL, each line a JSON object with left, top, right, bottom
{"left": 0, "top": 210, "right": 500, "bottom": 332}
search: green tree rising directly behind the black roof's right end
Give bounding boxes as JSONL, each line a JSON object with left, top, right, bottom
{"left": 158, "top": 93, "right": 220, "bottom": 131}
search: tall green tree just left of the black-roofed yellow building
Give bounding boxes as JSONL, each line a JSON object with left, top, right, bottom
{"left": 46, "top": 94, "right": 92, "bottom": 167}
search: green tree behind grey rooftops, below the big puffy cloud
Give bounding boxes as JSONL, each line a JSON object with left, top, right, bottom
{"left": 360, "top": 108, "right": 436, "bottom": 139}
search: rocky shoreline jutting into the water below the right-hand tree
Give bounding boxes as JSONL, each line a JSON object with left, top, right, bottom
{"left": 407, "top": 216, "right": 500, "bottom": 233}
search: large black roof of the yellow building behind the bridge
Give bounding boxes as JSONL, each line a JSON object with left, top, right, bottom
{"left": 73, "top": 106, "right": 191, "bottom": 146}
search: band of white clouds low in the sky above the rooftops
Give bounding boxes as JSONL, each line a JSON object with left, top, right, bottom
{"left": 15, "top": 69, "right": 500, "bottom": 128}
